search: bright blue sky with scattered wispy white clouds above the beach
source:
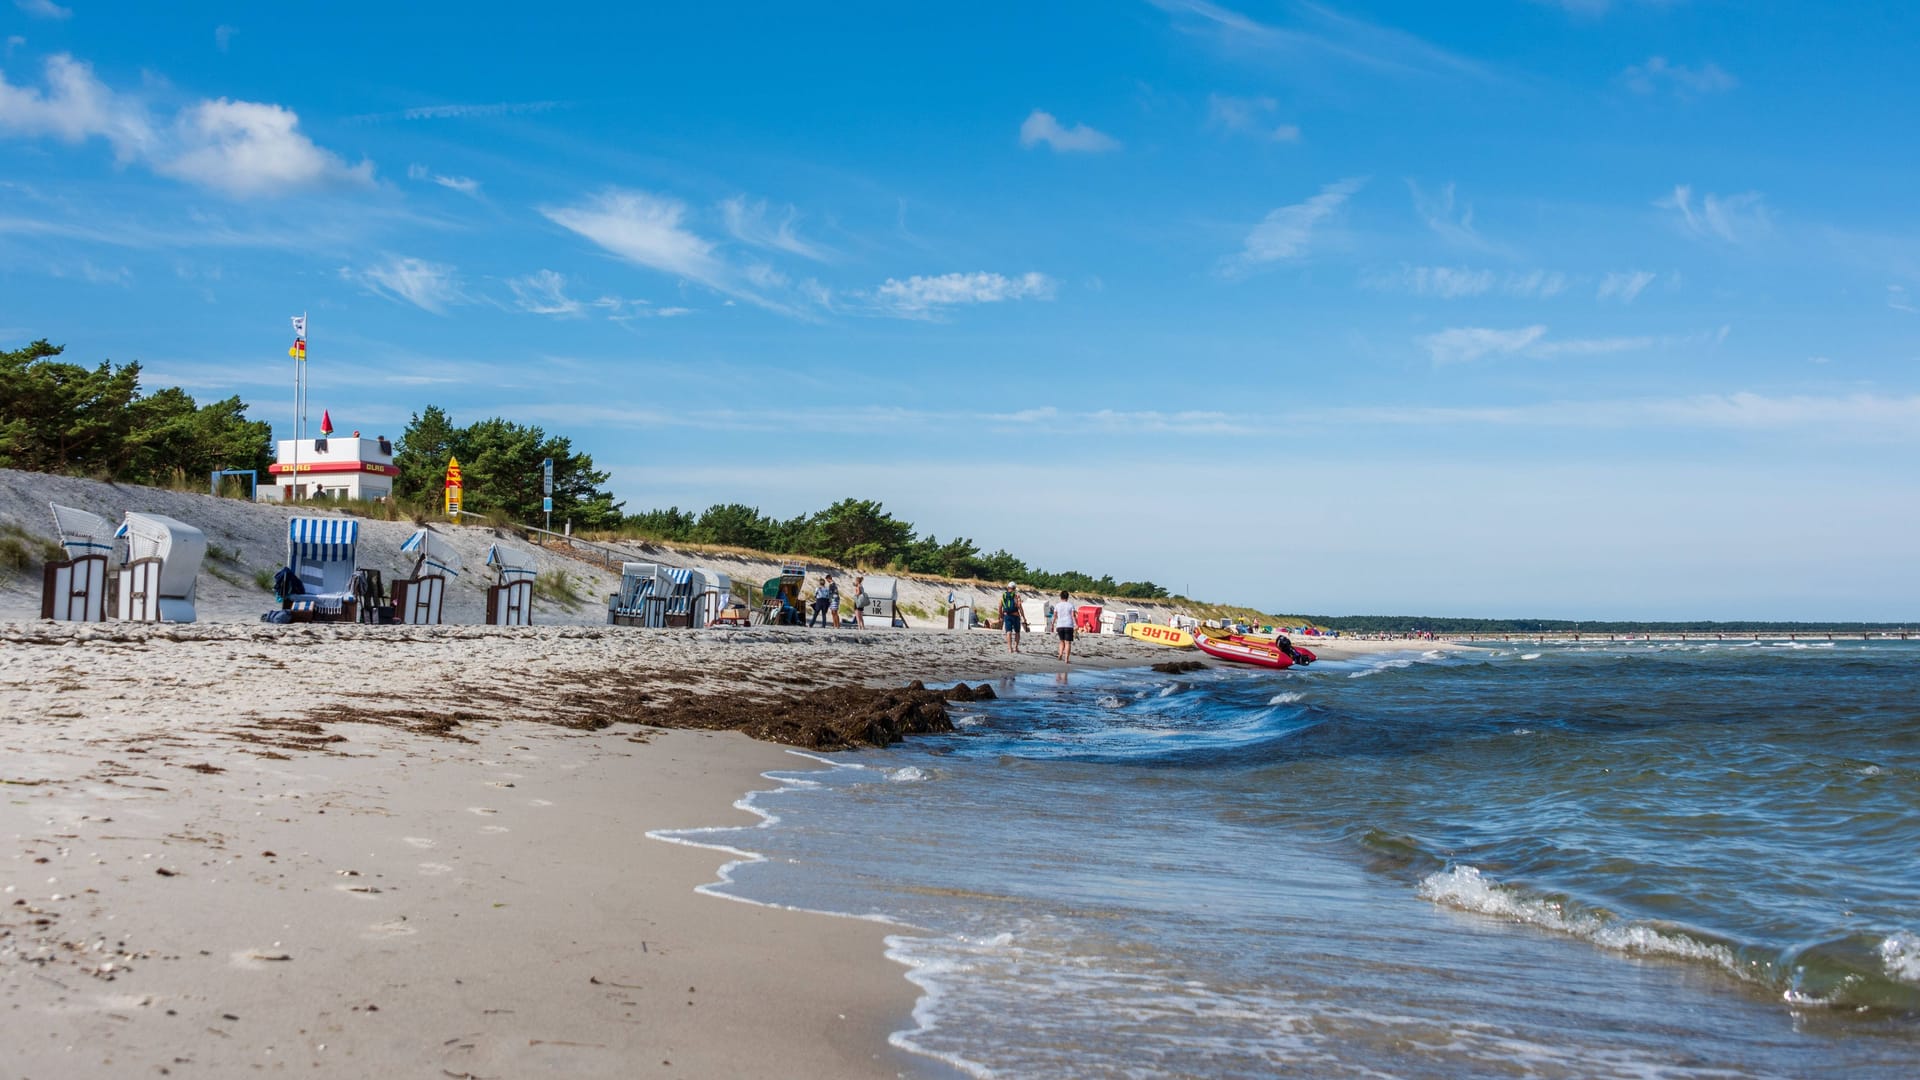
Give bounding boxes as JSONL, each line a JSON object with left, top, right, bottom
{"left": 0, "top": 0, "right": 1920, "bottom": 619}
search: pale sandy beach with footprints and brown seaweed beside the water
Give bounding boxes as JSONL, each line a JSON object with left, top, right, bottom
{"left": 0, "top": 623, "right": 1443, "bottom": 1076}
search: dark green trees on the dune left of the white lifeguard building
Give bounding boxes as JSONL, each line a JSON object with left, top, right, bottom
{"left": 0, "top": 338, "right": 273, "bottom": 484}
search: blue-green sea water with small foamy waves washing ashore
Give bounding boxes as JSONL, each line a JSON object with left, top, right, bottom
{"left": 656, "top": 642, "right": 1920, "bottom": 1078}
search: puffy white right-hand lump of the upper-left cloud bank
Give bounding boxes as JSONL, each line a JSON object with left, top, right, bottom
{"left": 154, "top": 98, "right": 372, "bottom": 196}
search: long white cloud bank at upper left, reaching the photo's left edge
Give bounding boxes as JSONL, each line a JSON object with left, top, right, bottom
{"left": 0, "top": 54, "right": 372, "bottom": 196}
